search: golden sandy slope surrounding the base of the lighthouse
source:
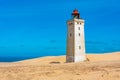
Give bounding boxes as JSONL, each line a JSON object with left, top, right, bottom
{"left": 0, "top": 52, "right": 120, "bottom": 80}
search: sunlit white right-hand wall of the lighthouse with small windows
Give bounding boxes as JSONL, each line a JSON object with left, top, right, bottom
{"left": 74, "top": 19, "right": 86, "bottom": 62}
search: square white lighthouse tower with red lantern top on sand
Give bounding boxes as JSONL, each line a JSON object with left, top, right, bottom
{"left": 66, "top": 10, "right": 86, "bottom": 62}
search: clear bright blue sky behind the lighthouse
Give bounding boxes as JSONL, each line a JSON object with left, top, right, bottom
{"left": 0, "top": 0, "right": 120, "bottom": 56}
